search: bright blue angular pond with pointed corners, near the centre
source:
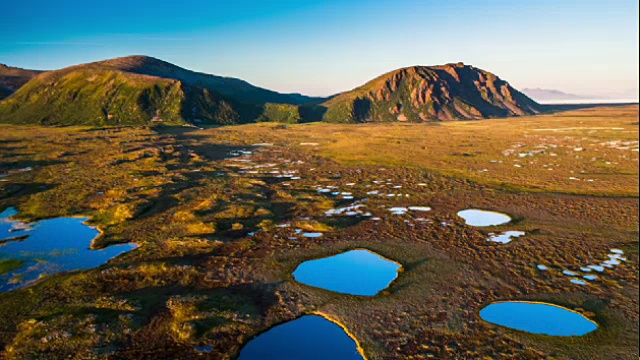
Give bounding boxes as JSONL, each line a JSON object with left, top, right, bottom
{"left": 293, "top": 250, "right": 400, "bottom": 296}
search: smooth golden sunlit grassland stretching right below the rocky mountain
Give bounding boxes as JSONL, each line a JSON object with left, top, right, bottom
{"left": 208, "top": 106, "right": 638, "bottom": 196}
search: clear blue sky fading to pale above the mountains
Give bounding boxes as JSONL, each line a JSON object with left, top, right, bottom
{"left": 0, "top": 0, "right": 638, "bottom": 95}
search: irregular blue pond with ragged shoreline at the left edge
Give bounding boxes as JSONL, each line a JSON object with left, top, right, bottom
{"left": 0, "top": 208, "right": 137, "bottom": 292}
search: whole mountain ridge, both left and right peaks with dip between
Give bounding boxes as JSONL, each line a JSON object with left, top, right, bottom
{"left": 0, "top": 55, "right": 541, "bottom": 126}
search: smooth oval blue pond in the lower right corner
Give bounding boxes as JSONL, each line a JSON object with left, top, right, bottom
{"left": 480, "top": 301, "right": 598, "bottom": 336}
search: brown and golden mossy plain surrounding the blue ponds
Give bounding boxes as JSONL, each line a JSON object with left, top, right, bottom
{"left": 0, "top": 107, "right": 639, "bottom": 359}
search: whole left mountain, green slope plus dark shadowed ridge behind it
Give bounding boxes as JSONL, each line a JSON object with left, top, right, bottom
{"left": 0, "top": 56, "right": 322, "bottom": 125}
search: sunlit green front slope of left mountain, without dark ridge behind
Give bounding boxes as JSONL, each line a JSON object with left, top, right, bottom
{"left": 0, "top": 68, "right": 266, "bottom": 125}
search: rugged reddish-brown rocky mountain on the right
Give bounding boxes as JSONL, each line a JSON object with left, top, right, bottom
{"left": 322, "top": 63, "right": 541, "bottom": 122}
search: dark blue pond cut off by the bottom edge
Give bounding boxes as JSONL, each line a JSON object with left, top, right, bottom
{"left": 238, "top": 315, "right": 363, "bottom": 360}
